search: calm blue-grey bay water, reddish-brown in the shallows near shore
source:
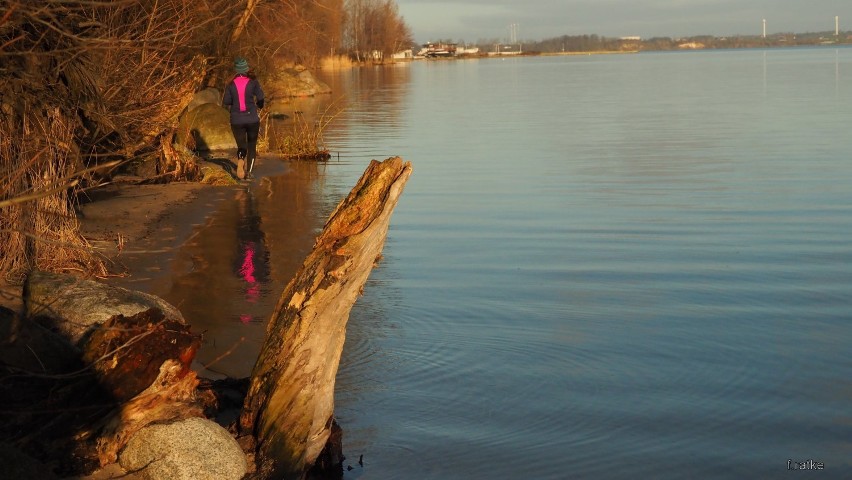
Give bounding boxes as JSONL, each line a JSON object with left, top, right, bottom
{"left": 115, "top": 48, "right": 852, "bottom": 480}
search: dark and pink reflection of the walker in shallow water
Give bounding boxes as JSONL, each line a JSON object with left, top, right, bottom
{"left": 234, "top": 188, "right": 269, "bottom": 323}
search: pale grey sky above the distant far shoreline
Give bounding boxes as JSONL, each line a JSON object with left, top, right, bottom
{"left": 397, "top": 0, "right": 852, "bottom": 43}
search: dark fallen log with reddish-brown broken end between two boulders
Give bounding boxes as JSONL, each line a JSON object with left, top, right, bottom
{"left": 0, "top": 307, "right": 204, "bottom": 477}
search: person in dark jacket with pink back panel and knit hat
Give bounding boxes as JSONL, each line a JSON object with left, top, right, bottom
{"left": 222, "top": 57, "right": 264, "bottom": 180}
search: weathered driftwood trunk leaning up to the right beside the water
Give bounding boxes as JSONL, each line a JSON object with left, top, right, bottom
{"left": 240, "top": 157, "right": 412, "bottom": 479}
